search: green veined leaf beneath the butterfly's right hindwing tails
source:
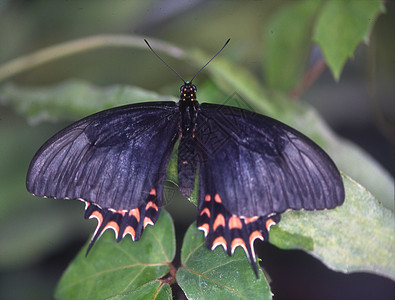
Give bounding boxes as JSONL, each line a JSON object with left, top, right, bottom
{"left": 177, "top": 223, "right": 271, "bottom": 299}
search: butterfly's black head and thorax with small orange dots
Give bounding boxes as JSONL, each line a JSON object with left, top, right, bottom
{"left": 179, "top": 81, "right": 199, "bottom": 137}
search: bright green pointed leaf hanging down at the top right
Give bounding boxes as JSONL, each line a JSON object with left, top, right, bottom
{"left": 314, "top": 0, "right": 384, "bottom": 80}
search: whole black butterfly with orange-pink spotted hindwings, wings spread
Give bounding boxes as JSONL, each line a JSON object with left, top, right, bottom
{"left": 26, "top": 40, "right": 344, "bottom": 274}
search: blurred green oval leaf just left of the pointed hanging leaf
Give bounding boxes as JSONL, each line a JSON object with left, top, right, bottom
{"left": 263, "top": 0, "right": 321, "bottom": 91}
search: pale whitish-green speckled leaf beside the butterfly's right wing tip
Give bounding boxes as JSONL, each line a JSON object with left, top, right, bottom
{"left": 270, "top": 176, "right": 395, "bottom": 280}
